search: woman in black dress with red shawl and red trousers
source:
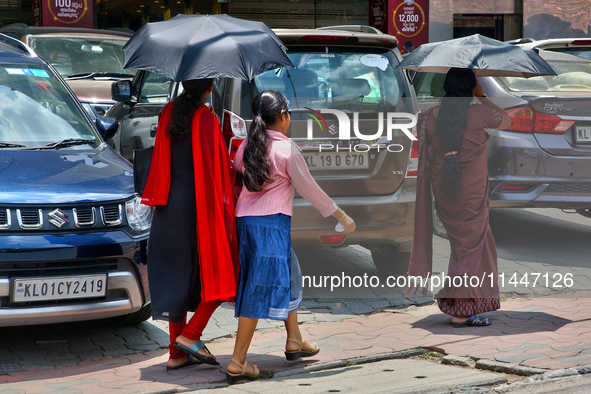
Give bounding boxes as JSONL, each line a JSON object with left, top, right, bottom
{"left": 142, "top": 79, "right": 239, "bottom": 370}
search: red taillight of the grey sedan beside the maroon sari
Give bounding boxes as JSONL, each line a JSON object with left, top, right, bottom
{"left": 507, "top": 107, "right": 575, "bottom": 134}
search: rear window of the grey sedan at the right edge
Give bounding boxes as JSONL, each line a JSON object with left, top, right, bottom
{"left": 495, "top": 61, "right": 591, "bottom": 93}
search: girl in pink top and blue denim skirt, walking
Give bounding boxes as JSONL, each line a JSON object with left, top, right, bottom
{"left": 226, "top": 90, "right": 355, "bottom": 383}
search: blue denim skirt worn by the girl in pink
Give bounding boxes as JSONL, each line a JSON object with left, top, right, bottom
{"left": 235, "top": 214, "right": 302, "bottom": 320}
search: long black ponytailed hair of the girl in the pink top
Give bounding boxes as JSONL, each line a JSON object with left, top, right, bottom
{"left": 242, "top": 90, "right": 289, "bottom": 192}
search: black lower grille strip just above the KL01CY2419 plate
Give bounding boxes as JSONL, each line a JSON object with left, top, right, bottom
{"left": 0, "top": 258, "right": 118, "bottom": 278}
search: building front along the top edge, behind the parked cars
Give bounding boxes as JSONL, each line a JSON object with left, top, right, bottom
{"left": 0, "top": 0, "right": 591, "bottom": 41}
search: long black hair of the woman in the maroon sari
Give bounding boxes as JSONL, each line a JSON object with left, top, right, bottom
{"left": 435, "top": 68, "right": 476, "bottom": 199}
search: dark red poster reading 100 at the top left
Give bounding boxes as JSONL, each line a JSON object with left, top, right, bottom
{"left": 33, "top": 0, "right": 93, "bottom": 29}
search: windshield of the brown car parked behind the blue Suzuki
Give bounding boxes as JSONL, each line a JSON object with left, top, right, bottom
{"left": 29, "top": 36, "right": 136, "bottom": 77}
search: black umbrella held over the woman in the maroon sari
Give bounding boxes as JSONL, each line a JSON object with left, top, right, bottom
{"left": 397, "top": 34, "right": 556, "bottom": 78}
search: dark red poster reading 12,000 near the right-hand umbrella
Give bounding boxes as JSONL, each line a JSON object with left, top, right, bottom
{"left": 388, "top": 0, "right": 429, "bottom": 53}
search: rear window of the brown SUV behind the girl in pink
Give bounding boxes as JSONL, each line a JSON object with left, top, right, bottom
{"left": 241, "top": 46, "right": 409, "bottom": 113}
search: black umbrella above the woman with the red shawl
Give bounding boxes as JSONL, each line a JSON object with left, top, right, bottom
{"left": 123, "top": 15, "right": 294, "bottom": 82}
